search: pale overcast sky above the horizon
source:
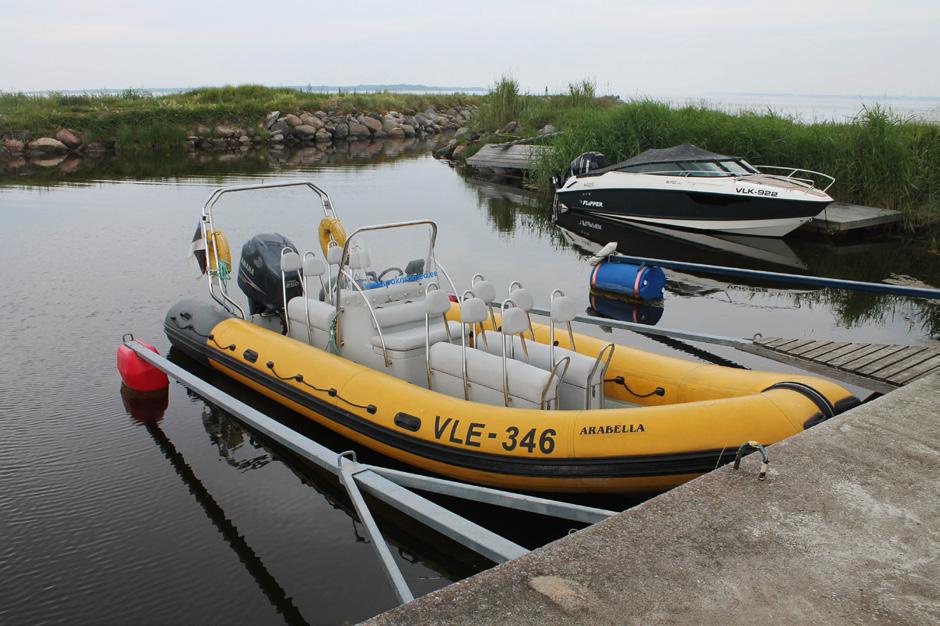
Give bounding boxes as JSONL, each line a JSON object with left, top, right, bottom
{"left": 0, "top": 0, "right": 940, "bottom": 97}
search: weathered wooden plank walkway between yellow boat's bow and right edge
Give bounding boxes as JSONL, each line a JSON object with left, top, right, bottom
{"left": 741, "top": 337, "right": 940, "bottom": 392}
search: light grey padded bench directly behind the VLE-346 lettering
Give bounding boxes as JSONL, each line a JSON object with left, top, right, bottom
{"left": 431, "top": 341, "right": 558, "bottom": 406}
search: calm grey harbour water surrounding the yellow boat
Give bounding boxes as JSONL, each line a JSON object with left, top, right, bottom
{"left": 0, "top": 143, "right": 940, "bottom": 624}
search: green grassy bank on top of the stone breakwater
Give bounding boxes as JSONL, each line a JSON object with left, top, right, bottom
{"left": 0, "top": 85, "right": 478, "bottom": 148}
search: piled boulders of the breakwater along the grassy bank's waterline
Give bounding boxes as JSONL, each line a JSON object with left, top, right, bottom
{"left": 0, "top": 105, "right": 476, "bottom": 160}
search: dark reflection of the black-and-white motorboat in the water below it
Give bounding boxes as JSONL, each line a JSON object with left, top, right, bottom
{"left": 557, "top": 207, "right": 807, "bottom": 270}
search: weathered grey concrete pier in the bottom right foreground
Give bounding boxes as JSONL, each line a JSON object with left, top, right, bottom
{"left": 371, "top": 373, "right": 940, "bottom": 626}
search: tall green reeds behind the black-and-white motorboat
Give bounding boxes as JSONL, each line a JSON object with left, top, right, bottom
{"left": 532, "top": 100, "right": 940, "bottom": 224}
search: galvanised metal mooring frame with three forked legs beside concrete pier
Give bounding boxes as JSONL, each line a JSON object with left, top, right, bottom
{"left": 124, "top": 339, "right": 615, "bottom": 603}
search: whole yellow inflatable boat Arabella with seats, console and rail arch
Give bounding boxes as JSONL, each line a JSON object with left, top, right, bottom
{"left": 165, "top": 183, "right": 858, "bottom": 493}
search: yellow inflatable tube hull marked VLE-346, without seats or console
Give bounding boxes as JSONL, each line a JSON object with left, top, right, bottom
{"left": 165, "top": 301, "right": 857, "bottom": 493}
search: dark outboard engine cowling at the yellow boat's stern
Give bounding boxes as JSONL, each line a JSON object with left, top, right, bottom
{"left": 238, "top": 233, "right": 301, "bottom": 315}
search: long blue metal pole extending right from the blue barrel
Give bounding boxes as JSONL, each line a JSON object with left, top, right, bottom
{"left": 606, "top": 254, "right": 940, "bottom": 300}
